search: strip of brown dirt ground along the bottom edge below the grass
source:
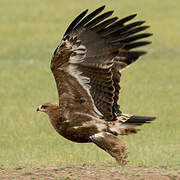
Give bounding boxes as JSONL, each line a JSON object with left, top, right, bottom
{"left": 0, "top": 165, "right": 180, "bottom": 180}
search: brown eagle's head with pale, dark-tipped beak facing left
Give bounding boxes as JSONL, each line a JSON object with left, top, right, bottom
{"left": 36, "top": 102, "right": 59, "bottom": 115}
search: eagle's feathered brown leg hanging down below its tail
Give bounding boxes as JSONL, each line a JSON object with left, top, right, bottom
{"left": 90, "top": 132, "right": 127, "bottom": 165}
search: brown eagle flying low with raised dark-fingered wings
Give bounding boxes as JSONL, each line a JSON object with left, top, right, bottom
{"left": 37, "top": 6, "right": 155, "bottom": 165}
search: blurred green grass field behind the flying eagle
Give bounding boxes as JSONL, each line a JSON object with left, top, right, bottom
{"left": 0, "top": 0, "right": 180, "bottom": 168}
